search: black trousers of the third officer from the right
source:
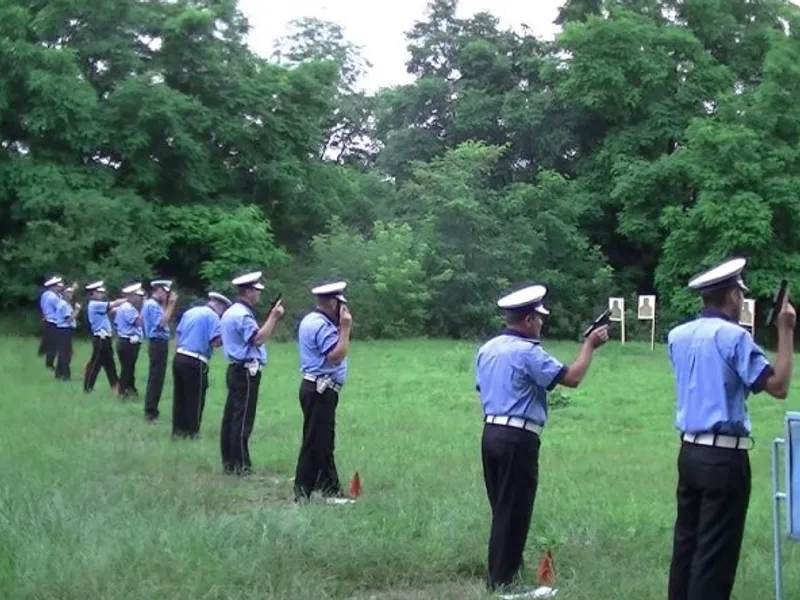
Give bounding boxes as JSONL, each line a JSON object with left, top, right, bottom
{"left": 294, "top": 380, "right": 341, "bottom": 499}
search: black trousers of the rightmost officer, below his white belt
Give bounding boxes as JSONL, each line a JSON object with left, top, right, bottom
{"left": 669, "top": 442, "right": 750, "bottom": 600}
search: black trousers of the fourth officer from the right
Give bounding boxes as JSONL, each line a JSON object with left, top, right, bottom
{"left": 220, "top": 364, "right": 261, "bottom": 474}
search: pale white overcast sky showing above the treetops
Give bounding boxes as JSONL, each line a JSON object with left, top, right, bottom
{"left": 239, "top": 0, "right": 562, "bottom": 91}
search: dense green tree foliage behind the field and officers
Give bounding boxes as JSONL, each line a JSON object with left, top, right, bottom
{"left": 0, "top": 0, "right": 800, "bottom": 337}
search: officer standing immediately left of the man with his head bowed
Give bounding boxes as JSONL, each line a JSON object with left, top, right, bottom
{"left": 142, "top": 279, "right": 178, "bottom": 421}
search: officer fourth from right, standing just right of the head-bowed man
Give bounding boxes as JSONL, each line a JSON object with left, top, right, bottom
{"left": 220, "top": 271, "right": 283, "bottom": 475}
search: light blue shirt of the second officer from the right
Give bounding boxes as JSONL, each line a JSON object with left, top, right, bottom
{"left": 475, "top": 330, "right": 567, "bottom": 426}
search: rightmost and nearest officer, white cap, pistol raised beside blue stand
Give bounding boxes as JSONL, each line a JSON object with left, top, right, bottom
{"left": 668, "top": 258, "right": 796, "bottom": 600}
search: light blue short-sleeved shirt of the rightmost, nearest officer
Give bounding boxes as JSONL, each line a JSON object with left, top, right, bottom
{"left": 668, "top": 310, "right": 772, "bottom": 437}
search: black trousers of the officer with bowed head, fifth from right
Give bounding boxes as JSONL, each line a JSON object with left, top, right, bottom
{"left": 172, "top": 354, "right": 208, "bottom": 437}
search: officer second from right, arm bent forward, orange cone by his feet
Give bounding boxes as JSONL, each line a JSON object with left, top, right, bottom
{"left": 475, "top": 285, "right": 608, "bottom": 591}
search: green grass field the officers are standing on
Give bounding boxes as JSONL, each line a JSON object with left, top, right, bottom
{"left": 0, "top": 338, "right": 800, "bottom": 600}
